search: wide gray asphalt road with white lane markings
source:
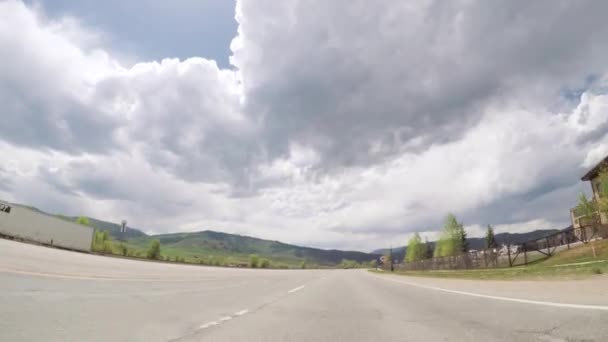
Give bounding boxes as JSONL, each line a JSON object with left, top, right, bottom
{"left": 0, "top": 240, "right": 608, "bottom": 342}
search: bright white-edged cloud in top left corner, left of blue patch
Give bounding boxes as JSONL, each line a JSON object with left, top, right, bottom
{"left": 0, "top": 1, "right": 117, "bottom": 153}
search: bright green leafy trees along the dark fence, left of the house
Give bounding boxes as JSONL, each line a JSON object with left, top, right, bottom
{"left": 404, "top": 214, "right": 498, "bottom": 262}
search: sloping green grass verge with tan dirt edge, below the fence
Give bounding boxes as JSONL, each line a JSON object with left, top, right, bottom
{"left": 382, "top": 240, "right": 608, "bottom": 280}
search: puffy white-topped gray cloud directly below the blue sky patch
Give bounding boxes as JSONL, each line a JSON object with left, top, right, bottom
{"left": 89, "top": 58, "right": 257, "bottom": 184}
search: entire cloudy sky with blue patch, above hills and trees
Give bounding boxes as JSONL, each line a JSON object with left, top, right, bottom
{"left": 0, "top": 0, "right": 608, "bottom": 251}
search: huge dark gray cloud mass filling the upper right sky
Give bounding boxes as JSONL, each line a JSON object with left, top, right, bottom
{"left": 233, "top": 0, "right": 608, "bottom": 171}
